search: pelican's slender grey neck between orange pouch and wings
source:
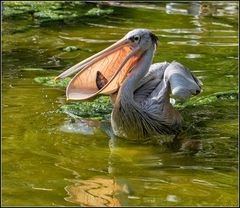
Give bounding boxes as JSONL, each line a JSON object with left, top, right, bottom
{"left": 120, "top": 46, "right": 155, "bottom": 100}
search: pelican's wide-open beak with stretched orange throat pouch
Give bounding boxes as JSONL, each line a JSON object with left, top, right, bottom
{"left": 56, "top": 38, "right": 141, "bottom": 100}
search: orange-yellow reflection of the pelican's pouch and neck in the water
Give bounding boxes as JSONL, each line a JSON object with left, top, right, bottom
{"left": 62, "top": 120, "right": 130, "bottom": 207}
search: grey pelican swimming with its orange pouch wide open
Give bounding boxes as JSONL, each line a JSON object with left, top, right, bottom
{"left": 56, "top": 29, "right": 202, "bottom": 140}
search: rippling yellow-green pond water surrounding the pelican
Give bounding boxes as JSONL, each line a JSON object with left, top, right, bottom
{"left": 2, "top": 2, "right": 238, "bottom": 206}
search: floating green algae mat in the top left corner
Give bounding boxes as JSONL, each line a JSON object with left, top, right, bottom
{"left": 3, "top": 1, "right": 114, "bottom": 24}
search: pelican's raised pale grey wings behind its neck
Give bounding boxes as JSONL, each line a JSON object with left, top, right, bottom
{"left": 134, "top": 61, "right": 202, "bottom": 106}
